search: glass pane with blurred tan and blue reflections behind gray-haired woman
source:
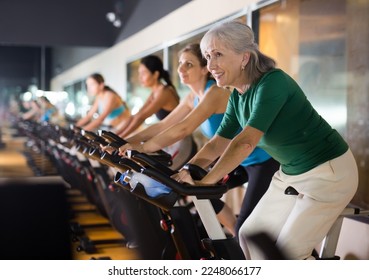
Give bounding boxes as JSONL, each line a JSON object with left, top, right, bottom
{"left": 258, "top": 0, "right": 347, "bottom": 135}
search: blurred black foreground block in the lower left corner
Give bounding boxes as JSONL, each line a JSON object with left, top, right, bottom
{"left": 0, "top": 177, "right": 72, "bottom": 260}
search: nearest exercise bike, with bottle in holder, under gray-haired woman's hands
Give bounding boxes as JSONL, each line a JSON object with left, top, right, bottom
{"left": 103, "top": 142, "right": 244, "bottom": 259}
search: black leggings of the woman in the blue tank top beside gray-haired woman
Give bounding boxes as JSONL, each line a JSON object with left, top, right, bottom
{"left": 211, "top": 158, "right": 279, "bottom": 238}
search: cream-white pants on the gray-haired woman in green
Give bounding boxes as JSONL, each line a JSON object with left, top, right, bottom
{"left": 239, "top": 150, "right": 358, "bottom": 259}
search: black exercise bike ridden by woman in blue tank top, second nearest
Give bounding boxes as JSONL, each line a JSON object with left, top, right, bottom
{"left": 72, "top": 127, "right": 178, "bottom": 259}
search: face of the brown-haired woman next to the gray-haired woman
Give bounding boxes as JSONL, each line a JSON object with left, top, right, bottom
{"left": 177, "top": 51, "right": 208, "bottom": 85}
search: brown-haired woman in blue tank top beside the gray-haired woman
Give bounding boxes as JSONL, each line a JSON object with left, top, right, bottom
{"left": 112, "top": 44, "right": 279, "bottom": 235}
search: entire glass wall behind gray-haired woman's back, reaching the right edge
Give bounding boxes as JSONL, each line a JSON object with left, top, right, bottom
{"left": 252, "top": 0, "right": 369, "bottom": 207}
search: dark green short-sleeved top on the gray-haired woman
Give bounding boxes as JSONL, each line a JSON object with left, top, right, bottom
{"left": 217, "top": 69, "right": 348, "bottom": 175}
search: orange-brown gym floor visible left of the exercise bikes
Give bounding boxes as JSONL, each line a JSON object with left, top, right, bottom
{"left": 0, "top": 126, "right": 139, "bottom": 260}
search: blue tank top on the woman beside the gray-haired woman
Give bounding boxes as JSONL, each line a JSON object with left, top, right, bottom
{"left": 194, "top": 80, "right": 271, "bottom": 166}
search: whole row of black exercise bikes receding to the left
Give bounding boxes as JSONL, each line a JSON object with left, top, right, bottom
{"left": 17, "top": 118, "right": 368, "bottom": 260}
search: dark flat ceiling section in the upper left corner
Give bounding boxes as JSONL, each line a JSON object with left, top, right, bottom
{"left": 0, "top": 0, "right": 140, "bottom": 47}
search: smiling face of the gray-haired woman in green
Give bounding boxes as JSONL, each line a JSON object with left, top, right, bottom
{"left": 204, "top": 38, "right": 249, "bottom": 89}
